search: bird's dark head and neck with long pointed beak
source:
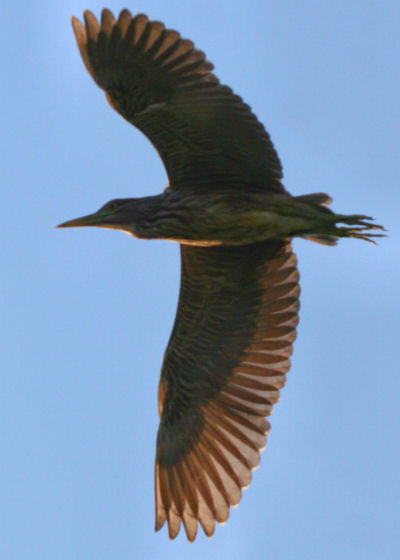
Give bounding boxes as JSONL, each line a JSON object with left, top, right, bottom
{"left": 57, "top": 197, "right": 156, "bottom": 237}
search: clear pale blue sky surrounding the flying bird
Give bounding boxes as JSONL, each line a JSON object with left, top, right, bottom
{"left": 0, "top": 0, "right": 400, "bottom": 560}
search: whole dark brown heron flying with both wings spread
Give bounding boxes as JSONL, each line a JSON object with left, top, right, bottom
{"left": 59, "top": 9, "right": 383, "bottom": 541}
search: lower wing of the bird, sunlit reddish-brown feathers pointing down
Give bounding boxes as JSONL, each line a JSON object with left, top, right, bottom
{"left": 156, "top": 241, "right": 300, "bottom": 540}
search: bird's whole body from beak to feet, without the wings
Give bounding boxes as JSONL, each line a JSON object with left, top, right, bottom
{"left": 62, "top": 188, "right": 378, "bottom": 247}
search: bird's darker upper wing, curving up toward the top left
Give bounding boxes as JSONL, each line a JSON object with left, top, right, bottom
{"left": 72, "top": 10, "right": 285, "bottom": 193}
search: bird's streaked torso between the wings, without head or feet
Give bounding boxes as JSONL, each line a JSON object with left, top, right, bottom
{"left": 138, "top": 189, "right": 316, "bottom": 247}
